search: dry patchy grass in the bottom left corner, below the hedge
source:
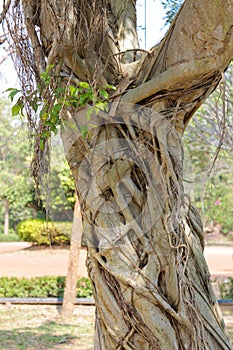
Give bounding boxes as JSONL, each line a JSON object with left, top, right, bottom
{"left": 0, "top": 305, "right": 94, "bottom": 350}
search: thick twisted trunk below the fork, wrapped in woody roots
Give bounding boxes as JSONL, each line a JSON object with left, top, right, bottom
{"left": 63, "top": 106, "right": 230, "bottom": 350}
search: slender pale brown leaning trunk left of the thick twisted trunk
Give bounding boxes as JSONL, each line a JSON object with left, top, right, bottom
{"left": 61, "top": 200, "right": 82, "bottom": 319}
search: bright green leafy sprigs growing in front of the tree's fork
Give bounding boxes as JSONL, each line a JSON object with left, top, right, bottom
{"left": 6, "top": 65, "right": 115, "bottom": 150}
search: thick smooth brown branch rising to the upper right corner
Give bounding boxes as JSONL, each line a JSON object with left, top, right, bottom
{"left": 121, "top": 0, "right": 233, "bottom": 121}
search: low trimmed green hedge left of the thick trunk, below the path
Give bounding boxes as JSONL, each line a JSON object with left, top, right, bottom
{"left": 0, "top": 276, "right": 93, "bottom": 298}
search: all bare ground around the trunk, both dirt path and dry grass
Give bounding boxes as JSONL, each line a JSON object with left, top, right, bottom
{"left": 0, "top": 243, "right": 233, "bottom": 350}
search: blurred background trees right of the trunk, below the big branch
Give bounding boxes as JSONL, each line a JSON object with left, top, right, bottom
{"left": 184, "top": 65, "right": 233, "bottom": 233}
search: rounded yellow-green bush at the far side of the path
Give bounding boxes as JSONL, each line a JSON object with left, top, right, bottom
{"left": 17, "top": 219, "right": 72, "bottom": 245}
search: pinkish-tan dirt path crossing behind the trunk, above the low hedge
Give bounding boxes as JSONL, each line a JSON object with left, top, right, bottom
{"left": 0, "top": 243, "right": 233, "bottom": 278}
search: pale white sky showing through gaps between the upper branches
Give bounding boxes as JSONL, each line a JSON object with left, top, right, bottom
{"left": 0, "top": 0, "right": 165, "bottom": 94}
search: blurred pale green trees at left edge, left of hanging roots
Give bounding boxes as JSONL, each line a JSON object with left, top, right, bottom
{"left": 0, "top": 100, "right": 34, "bottom": 234}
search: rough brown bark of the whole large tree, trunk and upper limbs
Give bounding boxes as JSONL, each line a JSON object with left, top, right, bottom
{"left": 13, "top": 0, "right": 233, "bottom": 350}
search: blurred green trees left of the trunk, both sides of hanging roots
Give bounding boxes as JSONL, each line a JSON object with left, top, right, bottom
{"left": 0, "top": 99, "right": 75, "bottom": 234}
